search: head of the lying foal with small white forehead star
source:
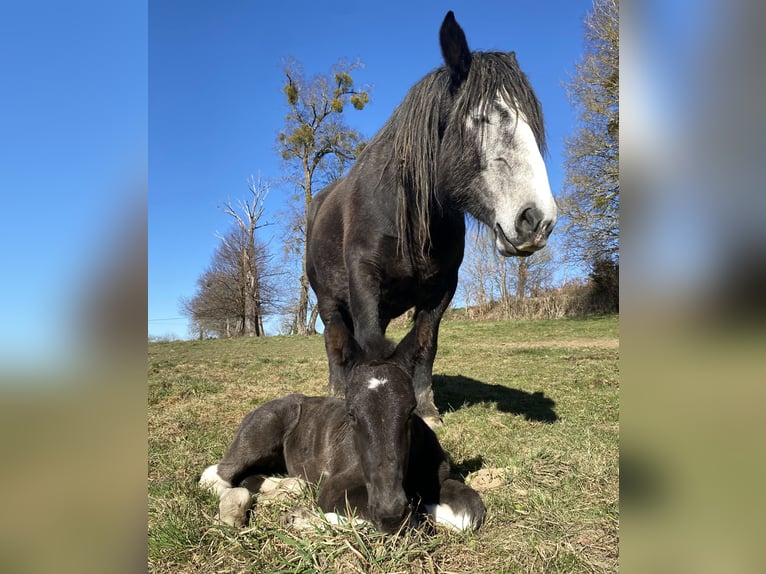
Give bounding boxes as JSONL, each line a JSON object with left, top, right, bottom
{"left": 326, "top": 324, "right": 424, "bottom": 532}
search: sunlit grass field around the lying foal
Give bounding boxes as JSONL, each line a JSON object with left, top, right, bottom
{"left": 148, "top": 316, "right": 619, "bottom": 574}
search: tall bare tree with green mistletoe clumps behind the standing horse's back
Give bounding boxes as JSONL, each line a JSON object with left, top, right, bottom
{"left": 277, "top": 61, "right": 369, "bottom": 334}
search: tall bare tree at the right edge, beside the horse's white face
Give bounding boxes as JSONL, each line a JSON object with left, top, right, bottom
{"left": 561, "top": 0, "right": 620, "bottom": 266}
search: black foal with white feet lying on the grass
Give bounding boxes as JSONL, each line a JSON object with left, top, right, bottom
{"left": 200, "top": 325, "right": 485, "bottom": 532}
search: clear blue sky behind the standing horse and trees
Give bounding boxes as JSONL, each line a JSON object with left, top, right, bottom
{"left": 148, "top": 0, "right": 590, "bottom": 337}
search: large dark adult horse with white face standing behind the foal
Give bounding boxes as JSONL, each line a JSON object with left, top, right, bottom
{"left": 306, "top": 12, "right": 556, "bottom": 425}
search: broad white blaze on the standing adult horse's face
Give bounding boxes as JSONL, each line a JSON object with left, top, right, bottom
{"left": 470, "top": 90, "right": 557, "bottom": 256}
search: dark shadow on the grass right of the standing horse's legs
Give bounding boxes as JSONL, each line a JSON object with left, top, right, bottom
{"left": 433, "top": 375, "right": 559, "bottom": 423}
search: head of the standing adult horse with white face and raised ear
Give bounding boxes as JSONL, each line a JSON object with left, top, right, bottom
{"left": 439, "top": 12, "right": 557, "bottom": 256}
